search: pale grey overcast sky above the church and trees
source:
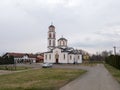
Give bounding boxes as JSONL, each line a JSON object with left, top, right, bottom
{"left": 0, "top": 0, "right": 120, "bottom": 54}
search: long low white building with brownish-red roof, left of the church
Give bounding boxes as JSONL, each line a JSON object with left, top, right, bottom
{"left": 3, "top": 53, "right": 36, "bottom": 63}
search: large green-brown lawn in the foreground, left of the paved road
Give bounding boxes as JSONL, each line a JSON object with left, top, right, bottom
{"left": 0, "top": 68, "right": 86, "bottom": 90}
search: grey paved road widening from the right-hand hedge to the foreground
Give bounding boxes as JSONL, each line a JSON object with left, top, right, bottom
{"left": 60, "top": 64, "right": 120, "bottom": 90}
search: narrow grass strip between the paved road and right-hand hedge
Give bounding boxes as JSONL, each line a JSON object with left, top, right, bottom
{"left": 105, "top": 64, "right": 120, "bottom": 83}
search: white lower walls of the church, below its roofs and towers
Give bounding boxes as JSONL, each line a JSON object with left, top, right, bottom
{"left": 44, "top": 48, "right": 82, "bottom": 63}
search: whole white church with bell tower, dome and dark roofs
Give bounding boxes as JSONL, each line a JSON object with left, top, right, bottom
{"left": 44, "top": 25, "right": 82, "bottom": 63}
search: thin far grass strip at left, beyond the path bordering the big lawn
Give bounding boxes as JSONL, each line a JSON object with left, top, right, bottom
{"left": 0, "top": 65, "right": 30, "bottom": 71}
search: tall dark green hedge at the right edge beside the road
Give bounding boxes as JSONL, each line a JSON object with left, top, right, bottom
{"left": 106, "top": 55, "right": 120, "bottom": 69}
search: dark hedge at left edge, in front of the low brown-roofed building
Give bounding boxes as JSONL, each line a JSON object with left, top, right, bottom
{"left": 0, "top": 56, "right": 14, "bottom": 65}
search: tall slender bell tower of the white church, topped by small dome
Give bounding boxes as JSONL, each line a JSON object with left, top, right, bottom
{"left": 48, "top": 24, "right": 56, "bottom": 51}
